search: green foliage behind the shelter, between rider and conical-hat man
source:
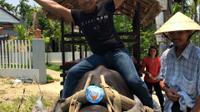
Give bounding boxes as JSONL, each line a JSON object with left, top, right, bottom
{"left": 114, "top": 15, "right": 156, "bottom": 59}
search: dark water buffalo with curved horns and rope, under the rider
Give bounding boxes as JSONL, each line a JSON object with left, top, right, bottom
{"left": 53, "top": 66, "right": 153, "bottom": 112}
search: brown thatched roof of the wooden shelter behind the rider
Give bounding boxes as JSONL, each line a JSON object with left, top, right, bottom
{"left": 54, "top": 0, "right": 161, "bottom": 26}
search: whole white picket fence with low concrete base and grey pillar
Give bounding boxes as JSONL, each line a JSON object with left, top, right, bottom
{"left": 0, "top": 39, "right": 46, "bottom": 83}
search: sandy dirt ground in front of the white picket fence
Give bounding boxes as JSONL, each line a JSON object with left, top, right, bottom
{"left": 0, "top": 70, "right": 62, "bottom": 110}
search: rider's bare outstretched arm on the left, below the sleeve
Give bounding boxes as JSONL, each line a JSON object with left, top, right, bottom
{"left": 35, "top": 0, "right": 73, "bottom": 23}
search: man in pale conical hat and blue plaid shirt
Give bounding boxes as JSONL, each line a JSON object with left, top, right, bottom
{"left": 155, "top": 12, "right": 200, "bottom": 112}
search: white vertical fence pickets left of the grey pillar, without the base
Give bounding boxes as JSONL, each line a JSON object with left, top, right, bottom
{"left": 0, "top": 40, "right": 32, "bottom": 69}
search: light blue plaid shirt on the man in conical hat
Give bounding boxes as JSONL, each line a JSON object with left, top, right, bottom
{"left": 160, "top": 43, "right": 200, "bottom": 110}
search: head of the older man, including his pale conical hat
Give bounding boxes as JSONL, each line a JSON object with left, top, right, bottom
{"left": 155, "top": 12, "right": 200, "bottom": 46}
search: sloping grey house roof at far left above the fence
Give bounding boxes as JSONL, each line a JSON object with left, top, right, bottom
{"left": 0, "top": 7, "right": 20, "bottom": 24}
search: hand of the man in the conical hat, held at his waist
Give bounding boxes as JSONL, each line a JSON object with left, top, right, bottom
{"left": 165, "top": 88, "right": 180, "bottom": 102}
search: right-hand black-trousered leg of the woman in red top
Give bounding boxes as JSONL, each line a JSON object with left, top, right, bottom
{"left": 154, "top": 82, "right": 164, "bottom": 110}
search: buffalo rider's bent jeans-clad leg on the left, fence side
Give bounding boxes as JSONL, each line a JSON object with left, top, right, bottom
{"left": 62, "top": 54, "right": 106, "bottom": 98}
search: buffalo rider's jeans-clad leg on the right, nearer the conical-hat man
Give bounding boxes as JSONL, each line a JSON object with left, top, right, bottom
{"left": 106, "top": 50, "right": 153, "bottom": 108}
